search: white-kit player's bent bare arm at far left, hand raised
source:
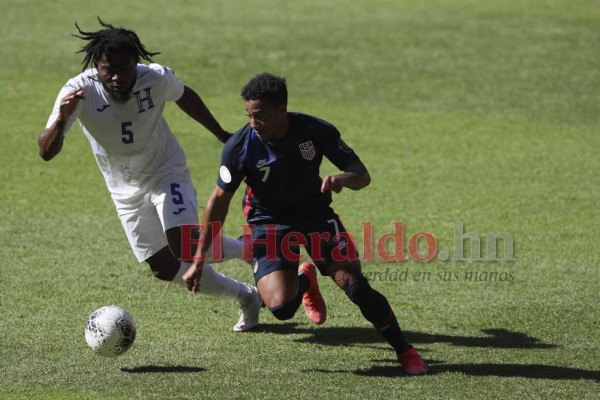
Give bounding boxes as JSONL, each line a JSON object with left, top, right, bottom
{"left": 38, "top": 88, "right": 85, "bottom": 161}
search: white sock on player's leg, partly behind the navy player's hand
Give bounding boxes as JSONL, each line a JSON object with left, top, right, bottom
{"left": 171, "top": 262, "right": 254, "bottom": 304}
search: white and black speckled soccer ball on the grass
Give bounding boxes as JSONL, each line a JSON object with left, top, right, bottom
{"left": 85, "top": 306, "right": 136, "bottom": 357}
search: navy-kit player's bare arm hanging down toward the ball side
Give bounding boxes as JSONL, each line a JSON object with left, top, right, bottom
{"left": 183, "top": 186, "right": 234, "bottom": 293}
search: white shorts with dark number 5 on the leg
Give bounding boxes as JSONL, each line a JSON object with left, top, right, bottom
{"left": 113, "top": 169, "right": 198, "bottom": 262}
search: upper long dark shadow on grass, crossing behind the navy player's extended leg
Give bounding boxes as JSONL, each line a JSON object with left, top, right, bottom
{"left": 254, "top": 323, "right": 558, "bottom": 349}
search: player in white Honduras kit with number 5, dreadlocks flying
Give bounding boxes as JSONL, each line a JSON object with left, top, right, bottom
{"left": 39, "top": 18, "right": 261, "bottom": 332}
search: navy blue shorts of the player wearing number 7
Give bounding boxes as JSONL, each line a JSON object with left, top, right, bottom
{"left": 250, "top": 209, "right": 358, "bottom": 282}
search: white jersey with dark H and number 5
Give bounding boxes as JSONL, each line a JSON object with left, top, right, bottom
{"left": 46, "top": 64, "right": 187, "bottom": 201}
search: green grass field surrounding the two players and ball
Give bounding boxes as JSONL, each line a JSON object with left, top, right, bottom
{"left": 0, "top": 0, "right": 600, "bottom": 399}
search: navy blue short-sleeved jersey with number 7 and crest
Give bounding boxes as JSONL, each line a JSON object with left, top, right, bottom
{"left": 217, "top": 112, "right": 359, "bottom": 223}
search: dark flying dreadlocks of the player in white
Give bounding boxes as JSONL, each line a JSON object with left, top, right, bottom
{"left": 72, "top": 17, "right": 160, "bottom": 71}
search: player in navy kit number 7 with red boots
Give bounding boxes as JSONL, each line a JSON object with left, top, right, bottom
{"left": 183, "top": 73, "right": 427, "bottom": 375}
